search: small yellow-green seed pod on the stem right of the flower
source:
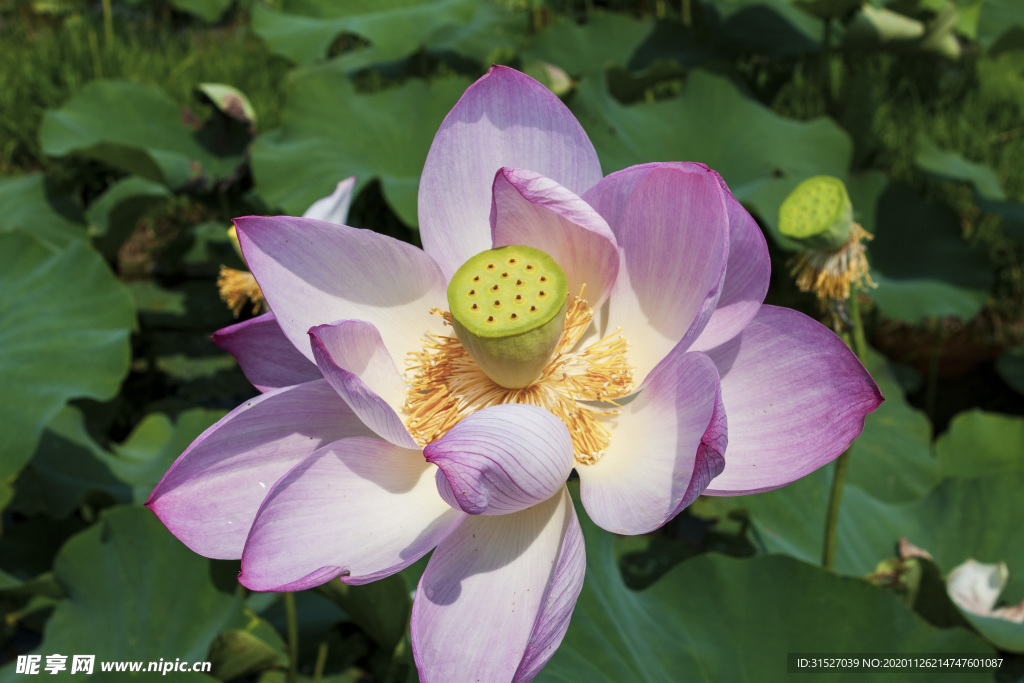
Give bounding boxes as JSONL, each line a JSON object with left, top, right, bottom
{"left": 778, "top": 175, "right": 853, "bottom": 251}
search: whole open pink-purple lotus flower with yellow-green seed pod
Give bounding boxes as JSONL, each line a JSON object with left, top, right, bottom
{"left": 147, "top": 67, "right": 882, "bottom": 681}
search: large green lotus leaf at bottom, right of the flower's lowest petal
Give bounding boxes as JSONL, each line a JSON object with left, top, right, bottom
{"left": 538, "top": 499, "right": 991, "bottom": 683}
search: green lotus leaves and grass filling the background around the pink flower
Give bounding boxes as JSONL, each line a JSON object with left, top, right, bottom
{"left": 0, "top": 0, "right": 1024, "bottom": 683}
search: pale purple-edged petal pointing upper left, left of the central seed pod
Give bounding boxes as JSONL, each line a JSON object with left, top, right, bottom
{"left": 234, "top": 216, "right": 446, "bottom": 367}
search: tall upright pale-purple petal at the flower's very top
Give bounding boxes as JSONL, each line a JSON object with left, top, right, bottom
{"left": 419, "top": 67, "right": 601, "bottom": 278}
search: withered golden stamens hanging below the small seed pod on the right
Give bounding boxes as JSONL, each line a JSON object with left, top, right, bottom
{"left": 790, "top": 223, "right": 874, "bottom": 308}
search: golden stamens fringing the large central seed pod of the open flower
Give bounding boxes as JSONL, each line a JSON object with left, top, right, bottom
{"left": 406, "top": 291, "right": 633, "bottom": 465}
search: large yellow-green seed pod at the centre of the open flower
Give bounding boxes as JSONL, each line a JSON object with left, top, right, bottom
{"left": 447, "top": 245, "right": 568, "bottom": 389}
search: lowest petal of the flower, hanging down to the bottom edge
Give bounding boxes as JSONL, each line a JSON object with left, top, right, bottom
{"left": 412, "top": 488, "right": 586, "bottom": 683}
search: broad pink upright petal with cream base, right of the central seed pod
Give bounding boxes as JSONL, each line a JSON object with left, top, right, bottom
{"left": 584, "top": 163, "right": 729, "bottom": 382}
